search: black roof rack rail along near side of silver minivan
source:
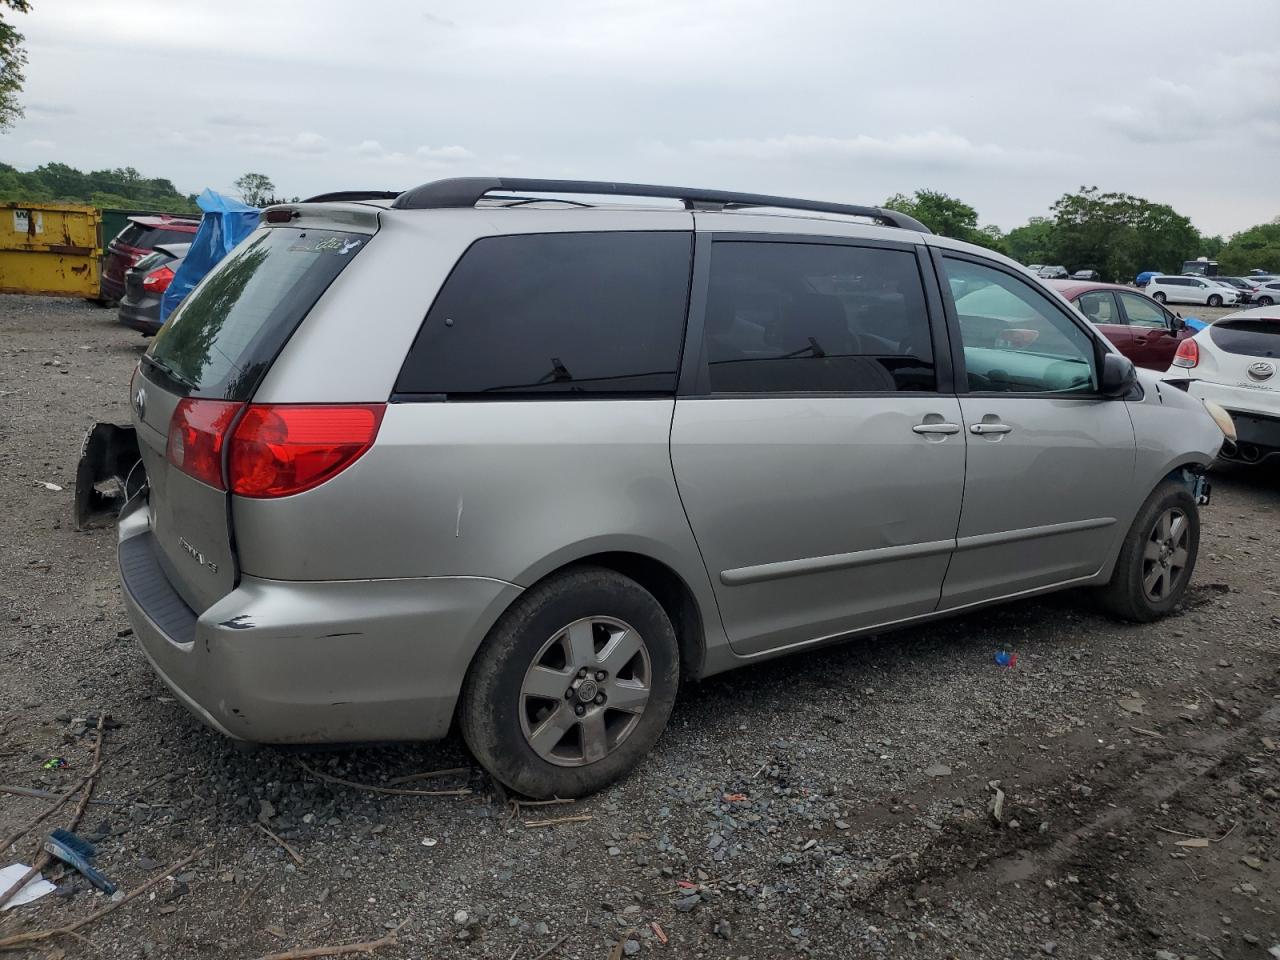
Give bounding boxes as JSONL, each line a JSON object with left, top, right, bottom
{"left": 392, "top": 177, "right": 929, "bottom": 233}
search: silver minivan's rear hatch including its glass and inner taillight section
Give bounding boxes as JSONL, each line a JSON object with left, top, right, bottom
{"left": 132, "top": 220, "right": 369, "bottom": 613}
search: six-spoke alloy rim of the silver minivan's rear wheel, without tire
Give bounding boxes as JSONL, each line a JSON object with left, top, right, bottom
{"left": 520, "top": 617, "right": 653, "bottom": 767}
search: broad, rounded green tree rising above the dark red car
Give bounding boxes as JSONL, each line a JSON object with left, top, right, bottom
{"left": 1052, "top": 187, "right": 1201, "bottom": 279}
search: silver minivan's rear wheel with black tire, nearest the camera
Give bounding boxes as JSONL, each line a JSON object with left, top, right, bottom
{"left": 460, "top": 567, "right": 680, "bottom": 799}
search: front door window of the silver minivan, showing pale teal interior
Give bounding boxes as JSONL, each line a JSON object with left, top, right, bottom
{"left": 943, "top": 257, "right": 1097, "bottom": 394}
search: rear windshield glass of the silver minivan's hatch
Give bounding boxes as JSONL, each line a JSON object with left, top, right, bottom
{"left": 147, "top": 227, "right": 369, "bottom": 401}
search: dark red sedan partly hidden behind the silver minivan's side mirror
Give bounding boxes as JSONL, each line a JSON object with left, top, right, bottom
{"left": 1047, "top": 280, "right": 1196, "bottom": 372}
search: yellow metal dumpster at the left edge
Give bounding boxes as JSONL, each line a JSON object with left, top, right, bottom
{"left": 0, "top": 202, "right": 102, "bottom": 300}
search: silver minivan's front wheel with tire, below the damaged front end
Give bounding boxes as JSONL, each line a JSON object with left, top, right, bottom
{"left": 1098, "top": 480, "right": 1199, "bottom": 623}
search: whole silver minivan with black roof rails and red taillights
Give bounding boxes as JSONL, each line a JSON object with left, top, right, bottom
{"left": 102, "top": 179, "right": 1230, "bottom": 796}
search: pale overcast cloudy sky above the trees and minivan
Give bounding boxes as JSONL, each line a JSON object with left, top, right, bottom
{"left": 0, "top": 0, "right": 1280, "bottom": 234}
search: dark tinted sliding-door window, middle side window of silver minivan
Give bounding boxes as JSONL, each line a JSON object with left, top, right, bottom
{"left": 704, "top": 241, "right": 937, "bottom": 393}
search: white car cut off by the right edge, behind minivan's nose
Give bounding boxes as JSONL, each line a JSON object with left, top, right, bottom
{"left": 1165, "top": 306, "right": 1280, "bottom": 463}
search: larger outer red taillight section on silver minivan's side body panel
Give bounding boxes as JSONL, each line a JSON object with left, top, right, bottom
{"left": 228, "top": 403, "right": 387, "bottom": 498}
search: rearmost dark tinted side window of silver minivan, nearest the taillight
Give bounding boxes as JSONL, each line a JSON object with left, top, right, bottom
{"left": 396, "top": 232, "right": 692, "bottom": 398}
